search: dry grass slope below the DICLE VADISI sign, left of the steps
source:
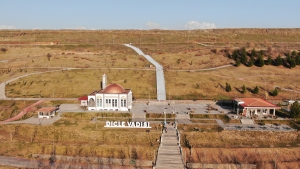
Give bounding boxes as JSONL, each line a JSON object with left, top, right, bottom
{"left": 0, "top": 113, "right": 160, "bottom": 160}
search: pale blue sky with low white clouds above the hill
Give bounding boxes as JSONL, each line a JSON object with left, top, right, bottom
{"left": 0, "top": 0, "right": 300, "bottom": 30}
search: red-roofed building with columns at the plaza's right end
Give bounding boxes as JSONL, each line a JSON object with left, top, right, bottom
{"left": 234, "top": 98, "right": 280, "bottom": 117}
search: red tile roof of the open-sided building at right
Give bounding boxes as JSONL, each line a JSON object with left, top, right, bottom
{"left": 234, "top": 98, "right": 280, "bottom": 108}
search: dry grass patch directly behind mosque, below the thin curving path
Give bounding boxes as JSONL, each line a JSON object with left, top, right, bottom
{"left": 6, "top": 69, "right": 156, "bottom": 98}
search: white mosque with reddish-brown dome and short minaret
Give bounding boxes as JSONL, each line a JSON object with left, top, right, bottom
{"left": 79, "top": 74, "right": 132, "bottom": 111}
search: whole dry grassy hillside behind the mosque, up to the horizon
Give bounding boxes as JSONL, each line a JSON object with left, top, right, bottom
{"left": 0, "top": 29, "right": 300, "bottom": 99}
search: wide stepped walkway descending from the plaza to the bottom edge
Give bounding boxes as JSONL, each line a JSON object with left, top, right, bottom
{"left": 155, "top": 124, "right": 184, "bottom": 169}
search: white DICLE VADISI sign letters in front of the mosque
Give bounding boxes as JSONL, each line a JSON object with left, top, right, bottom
{"left": 104, "top": 121, "right": 151, "bottom": 128}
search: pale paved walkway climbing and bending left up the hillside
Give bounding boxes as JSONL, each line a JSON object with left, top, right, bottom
{"left": 124, "top": 44, "right": 166, "bottom": 100}
